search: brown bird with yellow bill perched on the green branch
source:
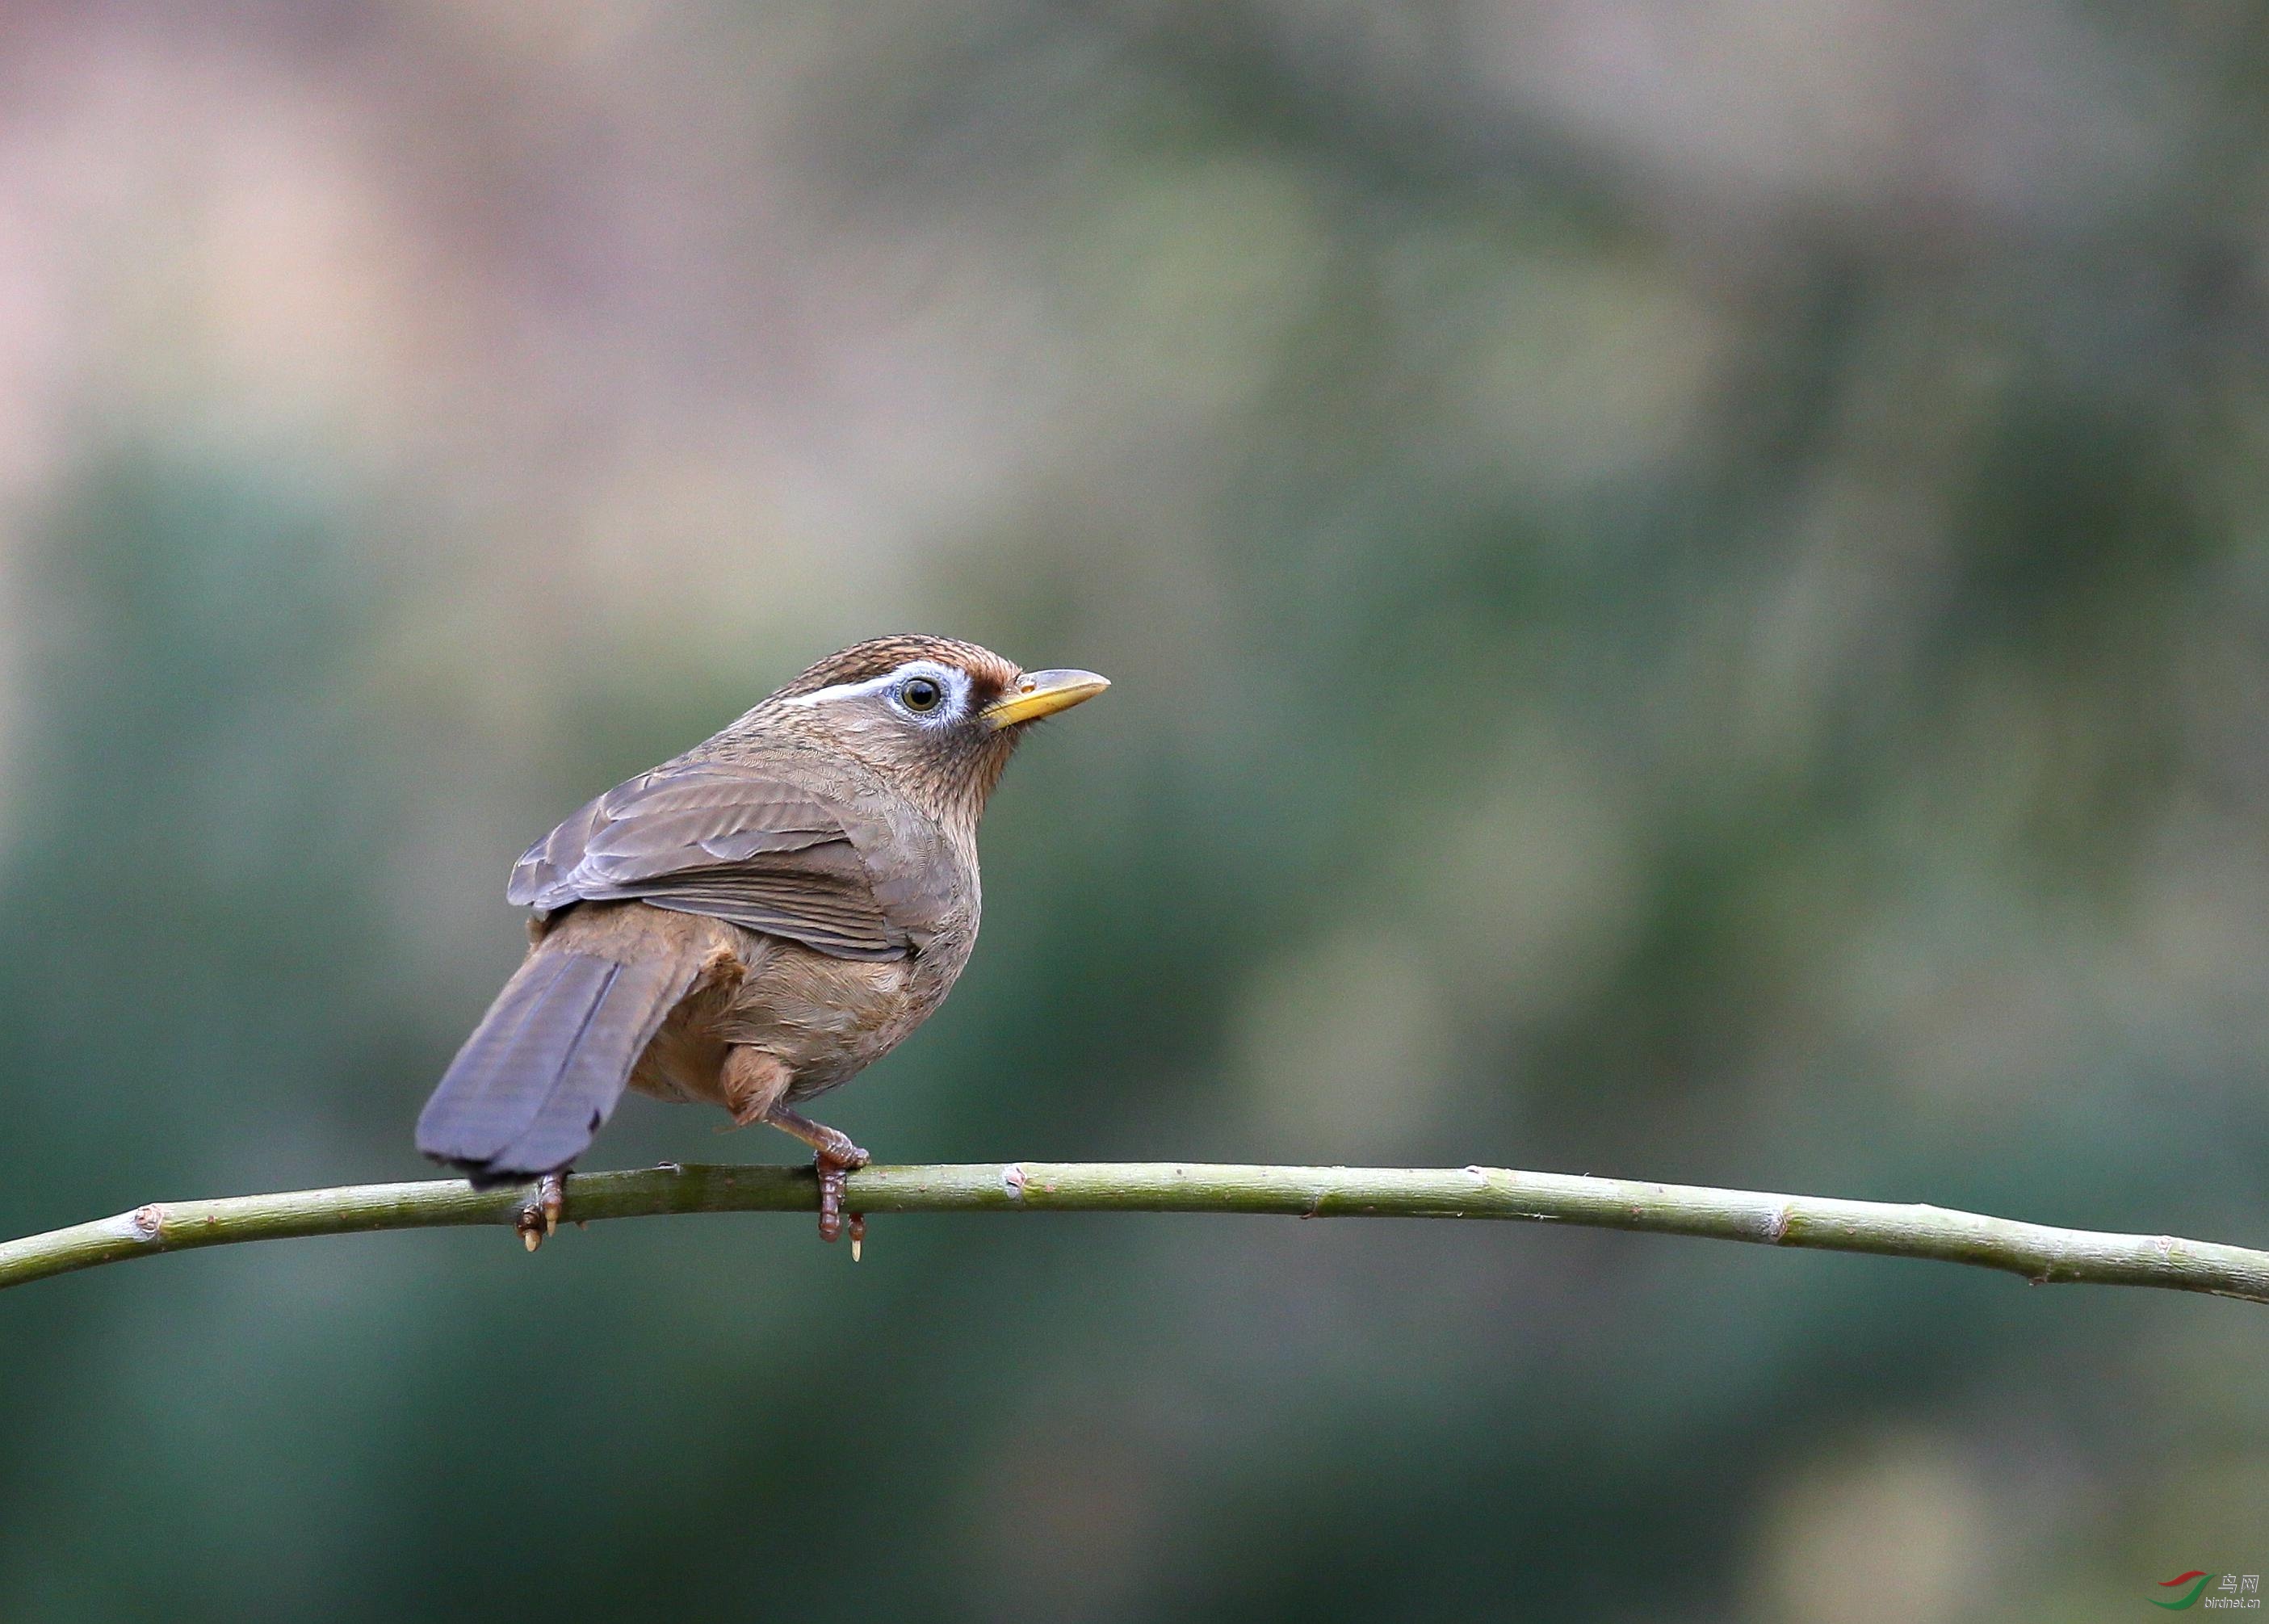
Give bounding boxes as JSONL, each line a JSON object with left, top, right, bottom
{"left": 417, "top": 635, "right": 1109, "bottom": 1250}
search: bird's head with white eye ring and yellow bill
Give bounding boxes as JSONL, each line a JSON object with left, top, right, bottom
{"left": 751, "top": 635, "right": 1109, "bottom": 819}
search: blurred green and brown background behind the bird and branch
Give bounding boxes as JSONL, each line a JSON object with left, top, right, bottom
{"left": 0, "top": 0, "right": 2269, "bottom": 1624}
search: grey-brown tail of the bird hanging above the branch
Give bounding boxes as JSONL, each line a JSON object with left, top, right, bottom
{"left": 417, "top": 948, "right": 698, "bottom": 1186}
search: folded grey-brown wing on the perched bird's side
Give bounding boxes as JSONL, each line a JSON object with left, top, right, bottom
{"left": 506, "top": 762, "right": 916, "bottom": 959}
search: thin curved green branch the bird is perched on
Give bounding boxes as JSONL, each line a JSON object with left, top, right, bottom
{"left": 0, "top": 1161, "right": 2269, "bottom": 1302}
